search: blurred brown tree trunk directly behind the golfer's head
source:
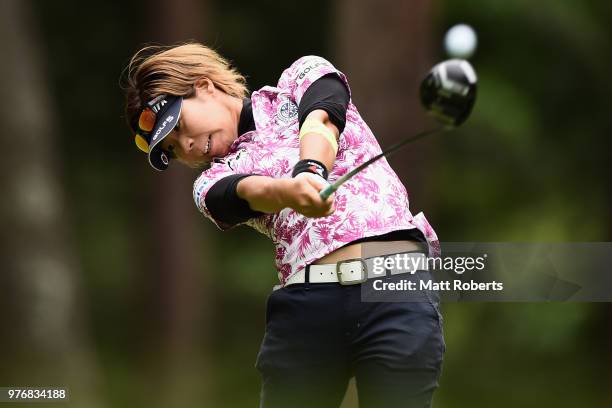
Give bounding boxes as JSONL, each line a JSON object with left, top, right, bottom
{"left": 143, "top": 0, "right": 214, "bottom": 407}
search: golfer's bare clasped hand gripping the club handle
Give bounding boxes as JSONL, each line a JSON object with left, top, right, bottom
{"left": 285, "top": 172, "right": 336, "bottom": 218}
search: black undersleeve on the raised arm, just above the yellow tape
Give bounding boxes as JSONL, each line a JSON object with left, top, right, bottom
{"left": 298, "top": 74, "right": 350, "bottom": 133}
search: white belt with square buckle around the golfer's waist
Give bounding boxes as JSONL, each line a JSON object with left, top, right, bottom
{"left": 275, "top": 252, "right": 428, "bottom": 289}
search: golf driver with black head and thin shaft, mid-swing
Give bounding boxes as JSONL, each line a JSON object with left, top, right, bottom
{"left": 319, "top": 59, "right": 477, "bottom": 200}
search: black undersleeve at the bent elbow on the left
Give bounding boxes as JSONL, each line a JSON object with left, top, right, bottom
{"left": 204, "top": 174, "right": 264, "bottom": 227}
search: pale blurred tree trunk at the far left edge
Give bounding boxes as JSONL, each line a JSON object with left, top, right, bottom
{"left": 0, "top": 0, "right": 104, "bottom": 407}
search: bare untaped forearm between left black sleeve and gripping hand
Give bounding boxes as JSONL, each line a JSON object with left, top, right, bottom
{"left": 236, "top": 176, "right": 288, "bottom": 214}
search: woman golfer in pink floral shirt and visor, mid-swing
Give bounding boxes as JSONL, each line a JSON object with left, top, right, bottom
{"left": 126, "top": 43, "right": 445, "bottom": 408}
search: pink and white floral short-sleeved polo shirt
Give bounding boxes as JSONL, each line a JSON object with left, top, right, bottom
{"left": 193, "top": 56, "right": 440, "bottom": 284}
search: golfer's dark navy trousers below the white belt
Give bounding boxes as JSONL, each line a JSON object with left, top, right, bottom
{"left": 255, "top": 275, "right": 446, "bottom": 408}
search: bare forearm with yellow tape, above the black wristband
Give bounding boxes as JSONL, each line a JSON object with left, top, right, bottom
{"left": 300, "top": 109, "right": 339, "bottom": 171}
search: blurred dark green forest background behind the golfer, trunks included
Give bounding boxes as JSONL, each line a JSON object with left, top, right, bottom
{"left": 0, "top": 0, "right": 612, "bottom": 408}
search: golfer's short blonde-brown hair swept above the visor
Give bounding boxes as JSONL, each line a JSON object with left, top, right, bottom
{"left": 122, "top": 42, "right": 248, "bottom": 129}
